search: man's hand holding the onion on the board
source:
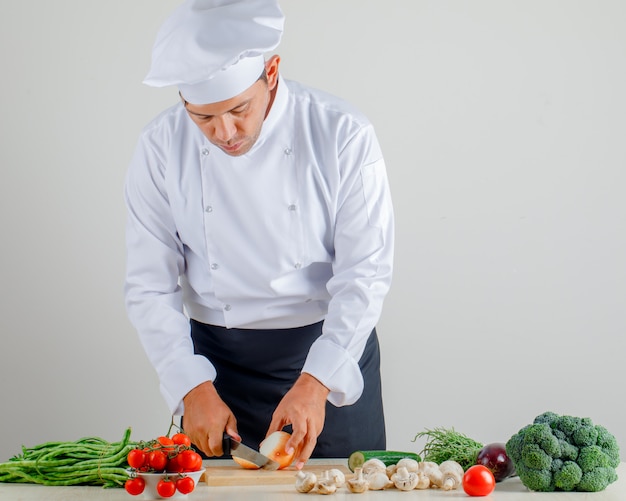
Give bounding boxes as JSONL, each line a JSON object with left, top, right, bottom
{"left": 267, "top": 373, "right": 330, "bottom": 470}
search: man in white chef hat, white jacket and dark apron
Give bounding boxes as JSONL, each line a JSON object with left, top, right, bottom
{"left": 125, "top": 0, "right": 393, "bottom": 468}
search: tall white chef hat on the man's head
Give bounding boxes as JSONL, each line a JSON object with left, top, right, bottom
{"left": 143, "top": 0, "right": 284, "bottom": 104}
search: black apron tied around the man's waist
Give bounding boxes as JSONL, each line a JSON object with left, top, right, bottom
{"left": 183, "top": 320, "right": 386, "bottom": 458}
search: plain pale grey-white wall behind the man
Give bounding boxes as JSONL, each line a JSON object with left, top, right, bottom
{"left": 0, "top": 0, "right": 626, "bottom": 460}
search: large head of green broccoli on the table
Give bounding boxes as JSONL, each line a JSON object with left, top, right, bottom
{"left": 506, "top": 412, "right": 620, "bottom": 492}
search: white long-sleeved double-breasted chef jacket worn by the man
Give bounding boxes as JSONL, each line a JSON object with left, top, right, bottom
{"left": 125, "top": 77, "right": 393, "bottom": 415}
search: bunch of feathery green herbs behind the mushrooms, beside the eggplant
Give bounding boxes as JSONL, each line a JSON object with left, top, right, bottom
{"left": 413, "top": 428, "right": 483, "bottom": 470}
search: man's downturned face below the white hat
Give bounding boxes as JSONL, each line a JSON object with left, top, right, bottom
{"left": 185, "top": 80, "right": 271, "bottom": 157}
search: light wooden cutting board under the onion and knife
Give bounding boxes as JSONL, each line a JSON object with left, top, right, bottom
{"left": 200, "top": 459, "right": 352, "bottom": 485}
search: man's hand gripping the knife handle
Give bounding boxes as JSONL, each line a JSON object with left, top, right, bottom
{"left": 183, "top": 381, "right": 241, "bottom": 457}
